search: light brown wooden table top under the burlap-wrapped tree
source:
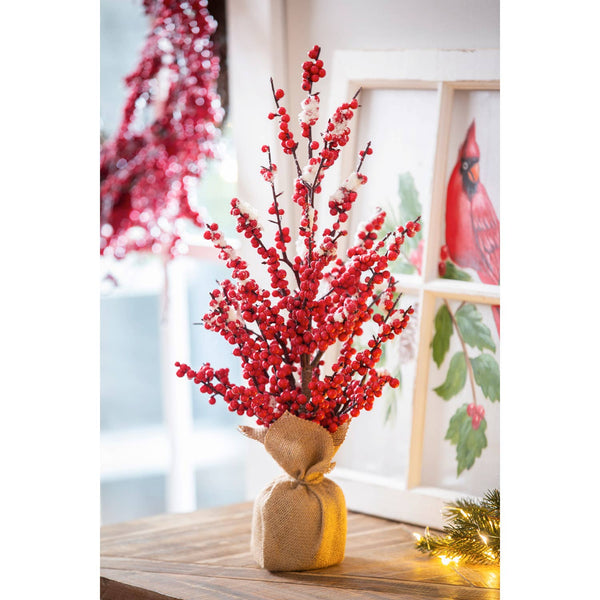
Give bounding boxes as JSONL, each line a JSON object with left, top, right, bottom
{"left": 100, "top": 503, "right": 500, "bottom": 600}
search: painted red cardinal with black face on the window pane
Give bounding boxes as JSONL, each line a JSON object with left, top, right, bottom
{"left": 446, "top": 120, "right": 500, "bottom": 333}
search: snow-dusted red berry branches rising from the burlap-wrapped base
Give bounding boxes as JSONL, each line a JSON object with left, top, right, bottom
{"left": 175, "top": 46, "right": 421, "bottom": 432}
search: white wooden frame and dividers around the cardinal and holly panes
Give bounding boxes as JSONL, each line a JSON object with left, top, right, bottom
{"left": 329, "top": 49, "right": 500, "bottom": 528}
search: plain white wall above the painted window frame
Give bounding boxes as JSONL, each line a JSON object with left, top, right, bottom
{"left": 283, "top": 0, "right": 500, "bottom": 134}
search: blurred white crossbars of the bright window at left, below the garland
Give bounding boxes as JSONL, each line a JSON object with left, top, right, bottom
{"left": 100, "top": 240, "right": 241, "bottom": 513}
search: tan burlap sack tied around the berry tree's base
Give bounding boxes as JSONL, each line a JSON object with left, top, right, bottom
{"left": 240, "top": 412, "right": 348, "bottom": 571}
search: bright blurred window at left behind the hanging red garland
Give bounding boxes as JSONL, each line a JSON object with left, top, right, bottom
{"left": 100, "top": 0, "right": 245, "bottom": 524}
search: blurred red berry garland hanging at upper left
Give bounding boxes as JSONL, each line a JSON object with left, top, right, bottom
{"left": 100, "top": 0, "right": 223, "bottom": 258}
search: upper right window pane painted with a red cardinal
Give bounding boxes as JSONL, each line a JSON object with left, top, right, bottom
{"left": 440, "top": 90, "right": 500, "bottom": 285}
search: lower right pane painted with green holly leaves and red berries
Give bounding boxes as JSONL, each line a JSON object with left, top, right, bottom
{"left": 422, "top": 299, "right": 500, "bottom": 495}
